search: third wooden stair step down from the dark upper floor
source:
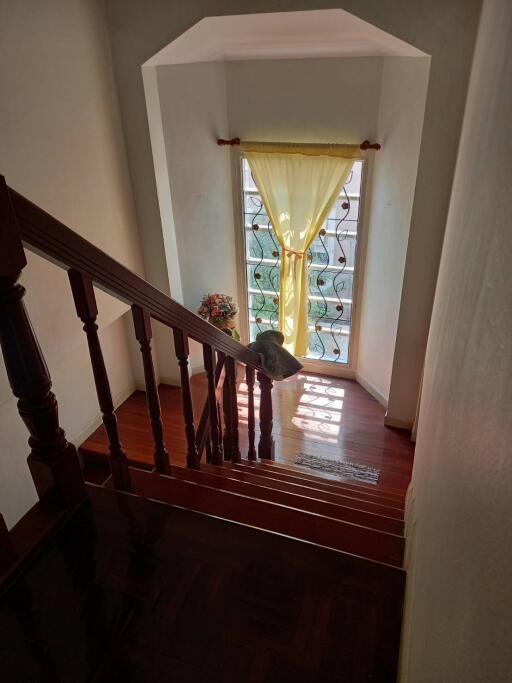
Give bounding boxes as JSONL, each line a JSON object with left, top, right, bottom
{"left": 201, "top": 465, "right": 403, "bottom": 522}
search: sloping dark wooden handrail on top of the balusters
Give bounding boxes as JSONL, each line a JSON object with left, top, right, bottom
{"left": 8, "top": 188, "right": 262, "bottom": 372}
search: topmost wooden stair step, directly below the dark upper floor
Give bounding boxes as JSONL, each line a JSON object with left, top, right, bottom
{"left": 123, "top": 469, "right": 404, "bottom": 567}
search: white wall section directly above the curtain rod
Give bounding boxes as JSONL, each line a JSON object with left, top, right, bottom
{"left": 226, "top": 57, "right": 382, "bottom": 143}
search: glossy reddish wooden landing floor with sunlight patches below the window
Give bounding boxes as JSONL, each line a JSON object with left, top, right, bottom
{"left": 82, "top": 373, "right": 414, "bottom": 492}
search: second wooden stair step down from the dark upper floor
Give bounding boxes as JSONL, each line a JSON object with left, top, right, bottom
{"left": 170, "top": 467, "right": 404, "bottom": 535}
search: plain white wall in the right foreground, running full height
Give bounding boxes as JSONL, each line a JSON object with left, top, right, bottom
{"left": 401, "top": 0, "right": 512, "bottom": 683}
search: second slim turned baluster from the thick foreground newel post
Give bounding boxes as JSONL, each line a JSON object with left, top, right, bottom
{"left": 132, "top": 306, "right": 170, "bottom": 474}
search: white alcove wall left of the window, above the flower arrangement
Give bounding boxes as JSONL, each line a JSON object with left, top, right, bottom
{"left": 157, "top": 62, "right": 236, "bottom": 311}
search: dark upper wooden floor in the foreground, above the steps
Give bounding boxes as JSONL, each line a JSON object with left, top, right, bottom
{"left": 0, "top": 485, "right": 403, "bottom": 683}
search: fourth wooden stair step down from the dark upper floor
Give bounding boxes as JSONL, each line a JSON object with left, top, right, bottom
{"left": 218, "top": 461, "right": 404, "bottom": 513}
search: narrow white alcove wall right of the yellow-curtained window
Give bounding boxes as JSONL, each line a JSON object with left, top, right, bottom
{"left": 357, "top": 57, "right": 430, "bottom": 406}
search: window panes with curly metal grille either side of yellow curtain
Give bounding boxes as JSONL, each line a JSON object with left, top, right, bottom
{"left": 242, "top": 157, "right": 363, "bottom": 365}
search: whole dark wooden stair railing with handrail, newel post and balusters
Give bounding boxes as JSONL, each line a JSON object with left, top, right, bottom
{"left": 0, "top": 176, "right": 274, "bottom": 512}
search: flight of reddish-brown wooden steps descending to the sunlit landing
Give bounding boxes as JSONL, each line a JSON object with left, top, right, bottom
{"left": 84, "top": 453, "right": 404, "bottom": 568}
